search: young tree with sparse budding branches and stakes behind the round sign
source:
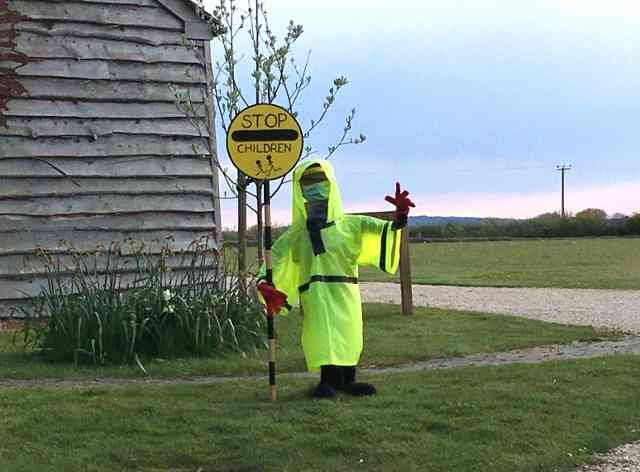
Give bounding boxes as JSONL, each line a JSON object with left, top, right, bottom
{"left": 182, "top": 0, "right": 366, "bottom": 288}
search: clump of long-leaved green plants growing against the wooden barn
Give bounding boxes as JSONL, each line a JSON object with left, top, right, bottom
{"left": 22, "top": 238, "right": 265, "bottom": 369}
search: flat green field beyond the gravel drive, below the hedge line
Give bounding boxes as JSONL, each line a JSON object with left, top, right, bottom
{"left": 361, "top": 238, "right": 640, "bottom": 289}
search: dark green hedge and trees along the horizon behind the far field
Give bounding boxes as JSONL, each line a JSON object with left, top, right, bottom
{"left": 409, "top": 208, "right": 640, "bottom": 239}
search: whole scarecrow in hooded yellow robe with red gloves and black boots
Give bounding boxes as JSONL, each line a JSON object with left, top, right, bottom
{"left": 258, "top": 160, "right": 415, "bottom": 397}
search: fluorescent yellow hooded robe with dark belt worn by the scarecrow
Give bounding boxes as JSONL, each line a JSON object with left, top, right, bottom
{"left": 259, "top": 159, "right": 401, "bottom": 372}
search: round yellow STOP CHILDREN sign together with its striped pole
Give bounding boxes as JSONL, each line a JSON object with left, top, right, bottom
{"left": 227, "top": 103, "right": 304, "bottom": 401}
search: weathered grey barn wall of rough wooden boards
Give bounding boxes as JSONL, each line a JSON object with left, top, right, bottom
{"left": 0, "top": 0, "right": 220, "bottom": 318}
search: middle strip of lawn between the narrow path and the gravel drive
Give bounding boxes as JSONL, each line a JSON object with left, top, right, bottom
{"left": 0, "top": 304, "right": 616, "bottom": 379}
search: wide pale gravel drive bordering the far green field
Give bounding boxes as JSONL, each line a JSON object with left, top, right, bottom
{"left": 360, "top": 282, "right": 640, "bottom": 333}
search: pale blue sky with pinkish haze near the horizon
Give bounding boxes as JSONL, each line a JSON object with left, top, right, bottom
{"left": 209, "top": 0, "right": 640, "bottom": 227}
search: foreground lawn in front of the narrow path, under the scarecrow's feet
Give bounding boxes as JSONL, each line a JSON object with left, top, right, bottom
{"left": 0, "top": 356, "right": 640, "bottom": 472}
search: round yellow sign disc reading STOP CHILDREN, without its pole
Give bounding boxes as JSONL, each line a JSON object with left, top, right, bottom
{"left": 227, "top": 104, "right": 303, "bottom": 180}
